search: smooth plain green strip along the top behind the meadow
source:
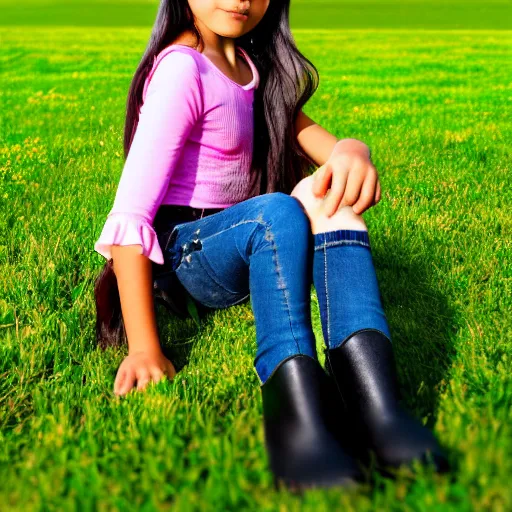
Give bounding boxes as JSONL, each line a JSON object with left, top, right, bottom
{"left": 0, "top": 0, "right": 512, "bottom": 30}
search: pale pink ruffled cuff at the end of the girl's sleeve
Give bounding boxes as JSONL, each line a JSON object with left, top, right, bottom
{"left": 94, "top": 213, "right": 164, "bottom": 265}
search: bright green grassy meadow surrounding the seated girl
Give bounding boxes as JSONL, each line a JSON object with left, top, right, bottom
{"left": 0, "top": 0, "right": 512, "bottom": 512}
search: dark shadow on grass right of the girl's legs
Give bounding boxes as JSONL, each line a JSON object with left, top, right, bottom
{"left": 372, "top": 232, "right": 458, "bottom": 428}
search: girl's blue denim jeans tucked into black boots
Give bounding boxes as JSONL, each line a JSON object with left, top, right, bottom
{"left": 164, "top": 192, "right": 390, "bottom": 383}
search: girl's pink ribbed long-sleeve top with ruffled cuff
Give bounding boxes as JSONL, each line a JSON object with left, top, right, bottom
{"left": 94, "top": 44, "right": 259, "bottom": 264}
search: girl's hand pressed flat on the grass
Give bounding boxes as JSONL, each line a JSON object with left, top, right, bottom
{"left": 114, "top": 350, "right": 176, "bottom": 395}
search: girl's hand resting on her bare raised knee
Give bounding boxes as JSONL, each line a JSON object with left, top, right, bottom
{"left": 313, "top": 149, "right": 381, "bottom": 217}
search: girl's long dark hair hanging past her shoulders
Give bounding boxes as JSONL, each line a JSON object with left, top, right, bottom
{"left": 94, "top": 0, "right": 319, "bottom": 348}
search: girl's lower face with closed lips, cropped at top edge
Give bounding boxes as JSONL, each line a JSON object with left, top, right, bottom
{"left": 188, "top": 0, "right": 270, "bottom": 39}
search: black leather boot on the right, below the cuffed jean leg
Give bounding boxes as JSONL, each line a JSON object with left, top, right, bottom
{"left": 326, "top": 329, "right": 449, "bottom": 472}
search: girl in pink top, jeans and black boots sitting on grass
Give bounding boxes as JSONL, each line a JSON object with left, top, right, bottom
{"left": 95, "top": 0, "right": 446, "bottom": 487}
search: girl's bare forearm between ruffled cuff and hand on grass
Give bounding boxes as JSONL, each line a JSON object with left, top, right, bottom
{"left": 112, "top": 245, "right": 161, "bottom": 353}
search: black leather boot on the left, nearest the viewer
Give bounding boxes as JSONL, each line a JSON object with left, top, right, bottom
{"left": 261, "top": 355, "right": 363, "bottom": 490}
